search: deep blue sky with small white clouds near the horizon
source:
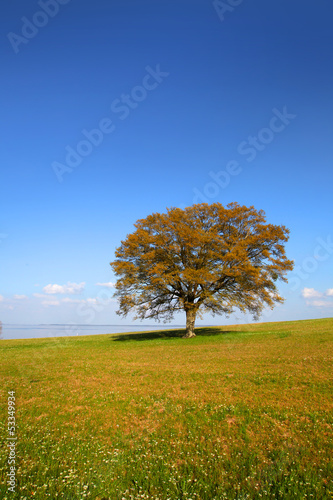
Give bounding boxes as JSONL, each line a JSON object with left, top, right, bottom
{"left": 0, "top": 0, "right": 333, "bottom": 324}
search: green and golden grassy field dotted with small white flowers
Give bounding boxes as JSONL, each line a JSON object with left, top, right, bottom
{"left": 0, "top": 319, "right": 333, "bottom": 500}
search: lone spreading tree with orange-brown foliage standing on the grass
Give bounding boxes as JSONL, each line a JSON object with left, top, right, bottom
{"left": 110, "top": 203, "right": 293, "bottom": 338}
